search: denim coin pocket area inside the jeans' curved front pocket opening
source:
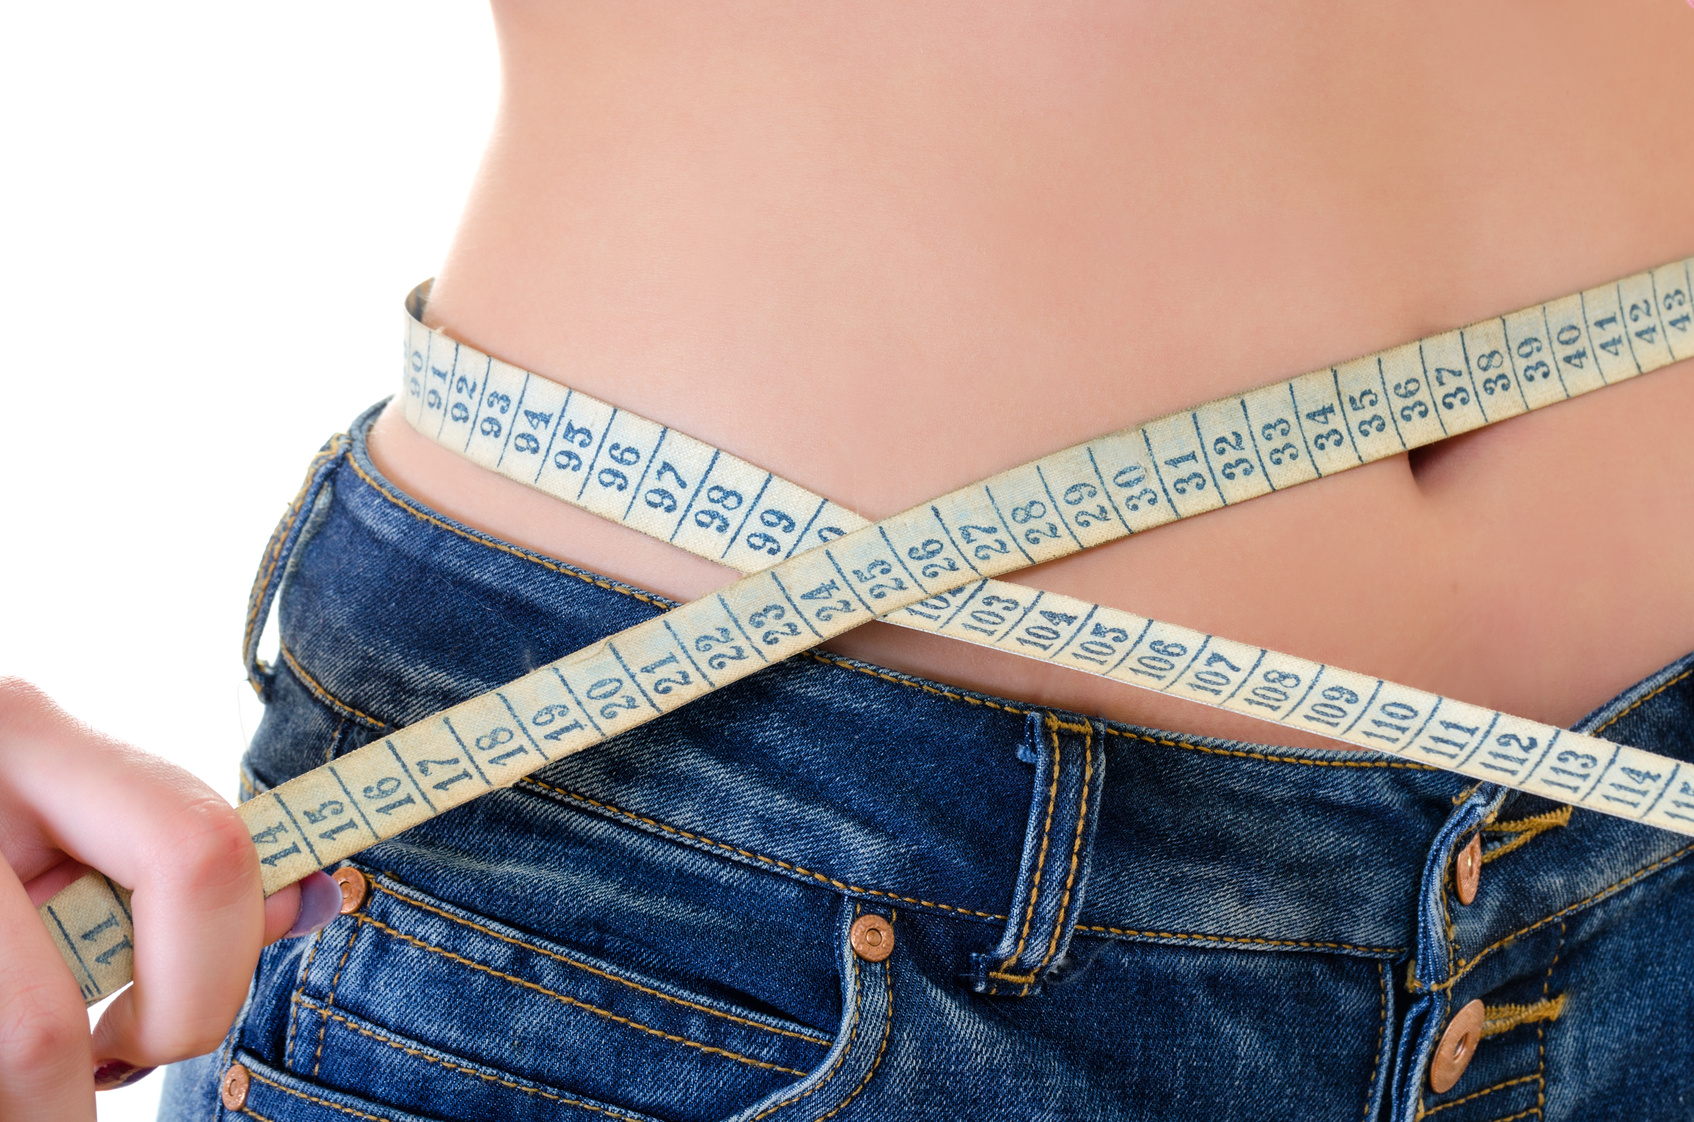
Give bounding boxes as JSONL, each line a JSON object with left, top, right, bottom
{"left": 286, "top": 876, "right": 835, "bottom": 1122}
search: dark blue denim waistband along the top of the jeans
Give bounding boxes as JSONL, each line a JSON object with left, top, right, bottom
{"left": 247, "top": 401, "right": 1687, "bottom": 993}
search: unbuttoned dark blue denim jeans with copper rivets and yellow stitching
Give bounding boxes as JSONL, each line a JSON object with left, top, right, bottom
{"left": 163, "top": 412, "right": 1694, "bottom": 1122}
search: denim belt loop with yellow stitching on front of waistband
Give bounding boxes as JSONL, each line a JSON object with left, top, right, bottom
{"left": 971, "top": 712, "right": 1106, "bottom": 997}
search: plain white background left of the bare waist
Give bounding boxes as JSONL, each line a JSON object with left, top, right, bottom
{"left": 0, "top": 0, "right": 498, "bottom": 1122}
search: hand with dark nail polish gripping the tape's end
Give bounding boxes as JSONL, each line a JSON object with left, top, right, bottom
{"left": 0, "top": 678, "right": 340, "bottom": 1122}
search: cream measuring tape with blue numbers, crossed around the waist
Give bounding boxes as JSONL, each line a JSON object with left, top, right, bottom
{"left": 41, "top": 259, "right": 1694, "bottom": 1003}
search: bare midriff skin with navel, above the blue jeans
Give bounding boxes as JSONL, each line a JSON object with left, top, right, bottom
{"left": 373, "top": 0, "right": 1694, "bottom": 747}
